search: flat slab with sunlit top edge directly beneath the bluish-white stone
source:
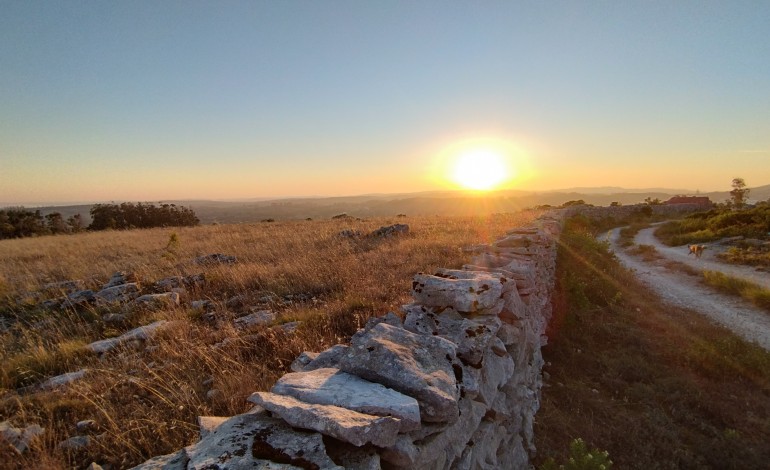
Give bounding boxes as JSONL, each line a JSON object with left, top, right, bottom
{"left": 249, "top": 392, "right": 400, "bottom": 447}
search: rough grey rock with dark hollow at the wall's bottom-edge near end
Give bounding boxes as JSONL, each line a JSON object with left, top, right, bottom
{"left": 182, "top": 411, "right": 342, "bottom": 470}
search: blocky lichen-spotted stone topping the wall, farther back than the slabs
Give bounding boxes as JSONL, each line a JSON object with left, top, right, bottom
{"left": 412, "top": 273, "right": 503, "bottom": 315}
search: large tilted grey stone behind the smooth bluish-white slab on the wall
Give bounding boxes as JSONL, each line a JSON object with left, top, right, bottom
{"left": 340, "top": 323, "right": 459, "bottom": 422}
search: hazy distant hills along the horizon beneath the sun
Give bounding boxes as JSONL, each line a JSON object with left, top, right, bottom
{"left": 15, "top": 185, "right": 770, "bottom": 224}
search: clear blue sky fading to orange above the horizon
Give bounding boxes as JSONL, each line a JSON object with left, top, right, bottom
{"left": 0, "top": 0, "right": 770, "bottom": 205}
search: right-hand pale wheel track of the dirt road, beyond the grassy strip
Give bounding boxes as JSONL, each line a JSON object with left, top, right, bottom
{"left": 634, "top": 227, "right": 770, "bottom": 289}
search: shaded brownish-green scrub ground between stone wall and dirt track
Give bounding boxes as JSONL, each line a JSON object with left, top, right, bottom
{"left": 535, "top": 217, "right": 770, "bottom": 469}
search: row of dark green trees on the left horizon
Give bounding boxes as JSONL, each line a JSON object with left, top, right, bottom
{"left": 0, "top": 202, "right": 200, "bottom": 239}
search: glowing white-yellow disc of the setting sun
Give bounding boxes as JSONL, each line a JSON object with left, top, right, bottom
{"left": 451, "top": 148, "right": 511, "bottom": 191}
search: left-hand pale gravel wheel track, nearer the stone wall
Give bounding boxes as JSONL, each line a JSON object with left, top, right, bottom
{"left": 601, "top": 228, "right": 770, "bottom": 351}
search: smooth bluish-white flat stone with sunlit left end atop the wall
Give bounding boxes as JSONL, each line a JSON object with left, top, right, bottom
{"left": 271, "top": 368, "right": 420, "bottom": 432}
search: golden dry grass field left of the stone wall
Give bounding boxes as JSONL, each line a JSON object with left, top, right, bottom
{"left": 0, "top": 212, "right": 538, "bottom": 469}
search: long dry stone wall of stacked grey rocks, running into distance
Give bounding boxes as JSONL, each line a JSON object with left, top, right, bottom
{"left": 136, "top": 214, "right": 560, "bottom": 469}
